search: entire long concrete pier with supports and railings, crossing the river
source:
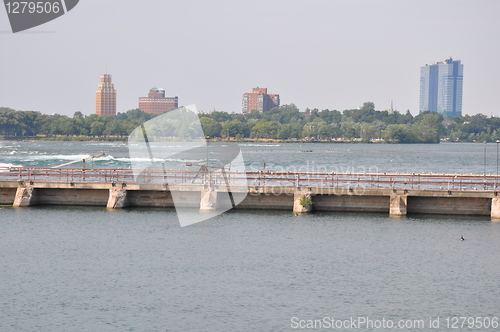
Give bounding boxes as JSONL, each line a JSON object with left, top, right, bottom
{"left": 0, "top": 168, "right": 500, "bottom": 218}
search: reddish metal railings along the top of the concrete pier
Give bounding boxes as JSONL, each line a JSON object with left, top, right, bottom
{"left": 0, "top": 167, "right": 500, "bottom": 191}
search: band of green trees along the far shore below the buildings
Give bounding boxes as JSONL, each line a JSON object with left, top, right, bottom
{"left": 0, "top": 102, "right": 500, "bottom": 143}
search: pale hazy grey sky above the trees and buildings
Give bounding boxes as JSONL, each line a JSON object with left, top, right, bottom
{"left": 0, "top": 0, "right": 500, "bottom": 116}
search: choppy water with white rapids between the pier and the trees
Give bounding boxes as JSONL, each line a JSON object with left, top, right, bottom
{"left": 0, "top": 141, "right": 497, "bottom": 174}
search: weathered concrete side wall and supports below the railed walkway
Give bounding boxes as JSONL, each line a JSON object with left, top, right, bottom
{"left": 0, "top": 181, "right": 494, "bottom": 219}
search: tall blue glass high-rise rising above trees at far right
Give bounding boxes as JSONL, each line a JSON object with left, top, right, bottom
{"left": 419, "top": 57, "right": 464, "bottom": 117}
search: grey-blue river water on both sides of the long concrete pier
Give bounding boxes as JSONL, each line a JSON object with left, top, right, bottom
{"left": 0, "top": 142, "right": 500, "bottom": 331}
